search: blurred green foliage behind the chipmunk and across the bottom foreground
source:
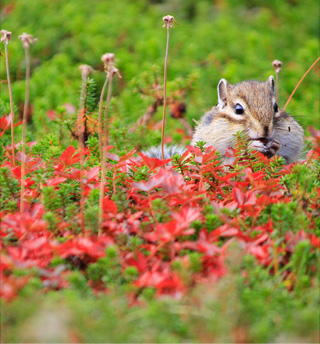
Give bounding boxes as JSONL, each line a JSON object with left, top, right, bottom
{"left": 0, "top": 0, "right": 320, "bottom": 342}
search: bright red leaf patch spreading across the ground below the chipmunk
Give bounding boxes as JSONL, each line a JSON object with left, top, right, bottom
{"left": 0, "top": 127, "right": 320, "bottom": 300}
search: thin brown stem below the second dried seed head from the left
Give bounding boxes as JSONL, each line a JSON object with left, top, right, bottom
{"left": 20, "top": 47, "right": 30, "bottom": 214}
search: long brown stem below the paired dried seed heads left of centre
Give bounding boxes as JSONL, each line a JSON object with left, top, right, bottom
{"left": 98, "top": 73, "right": 112, "bottom": 235}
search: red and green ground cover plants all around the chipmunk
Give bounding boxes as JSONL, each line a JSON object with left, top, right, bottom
{"left": 0, "top": 0, "right": 320, "bottom": 342}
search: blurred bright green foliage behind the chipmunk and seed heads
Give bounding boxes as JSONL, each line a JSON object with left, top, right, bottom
{"left": 0, "top": 0, "right": 320, "bottom": 146}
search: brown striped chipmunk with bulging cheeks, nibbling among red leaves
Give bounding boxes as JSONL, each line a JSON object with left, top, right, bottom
{"left": 147, "top": 76, "right": 304, "bottom": 165}
